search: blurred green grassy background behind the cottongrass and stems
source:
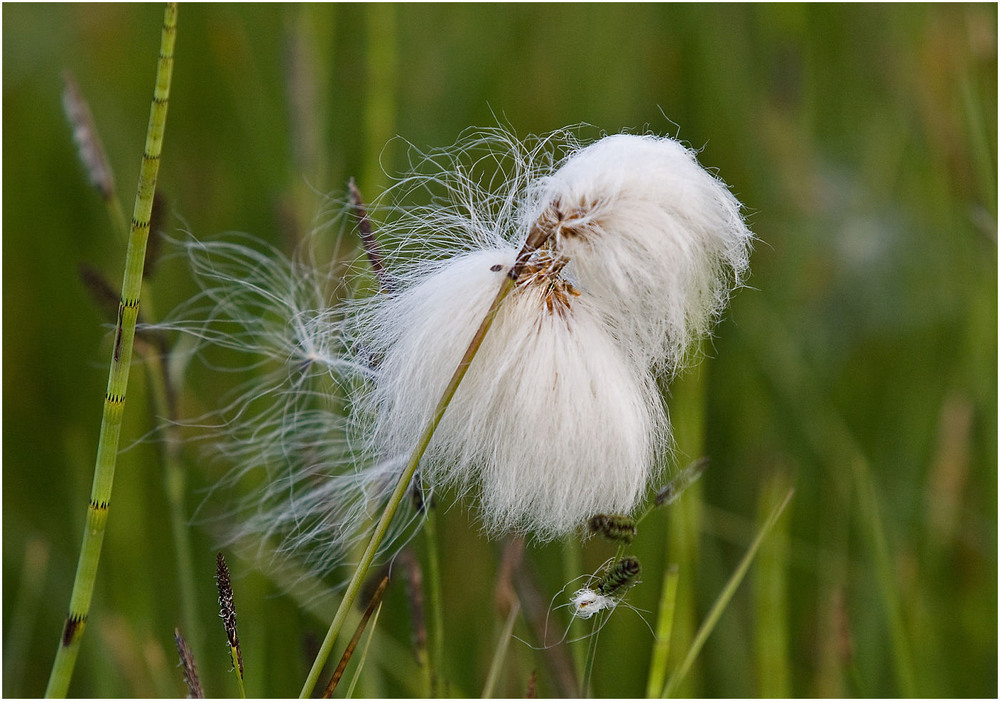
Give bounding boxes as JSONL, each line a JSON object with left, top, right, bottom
{"left": 3, "top": 4, "right": 997, "bottom": 697}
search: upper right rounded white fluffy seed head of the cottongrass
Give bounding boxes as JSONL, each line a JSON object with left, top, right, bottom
{"left": 524, "top": 134, "right": 753, "bottom": 372}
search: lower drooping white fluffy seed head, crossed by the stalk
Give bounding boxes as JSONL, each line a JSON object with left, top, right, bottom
{"left": 357, "top": 243, "right": 667, "bottom": 540}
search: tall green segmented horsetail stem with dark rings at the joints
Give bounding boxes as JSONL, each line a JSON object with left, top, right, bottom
{"left": 45, "top": 3, "right": 177, "bottom": 697}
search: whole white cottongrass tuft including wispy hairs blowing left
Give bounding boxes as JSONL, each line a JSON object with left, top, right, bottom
{"left": 156, "top": 130, "right": 752, "bottom": 572}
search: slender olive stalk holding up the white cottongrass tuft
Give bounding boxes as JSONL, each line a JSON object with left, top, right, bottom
{"left": 299, "top": 226, "right": 551, "bottom": 698}
